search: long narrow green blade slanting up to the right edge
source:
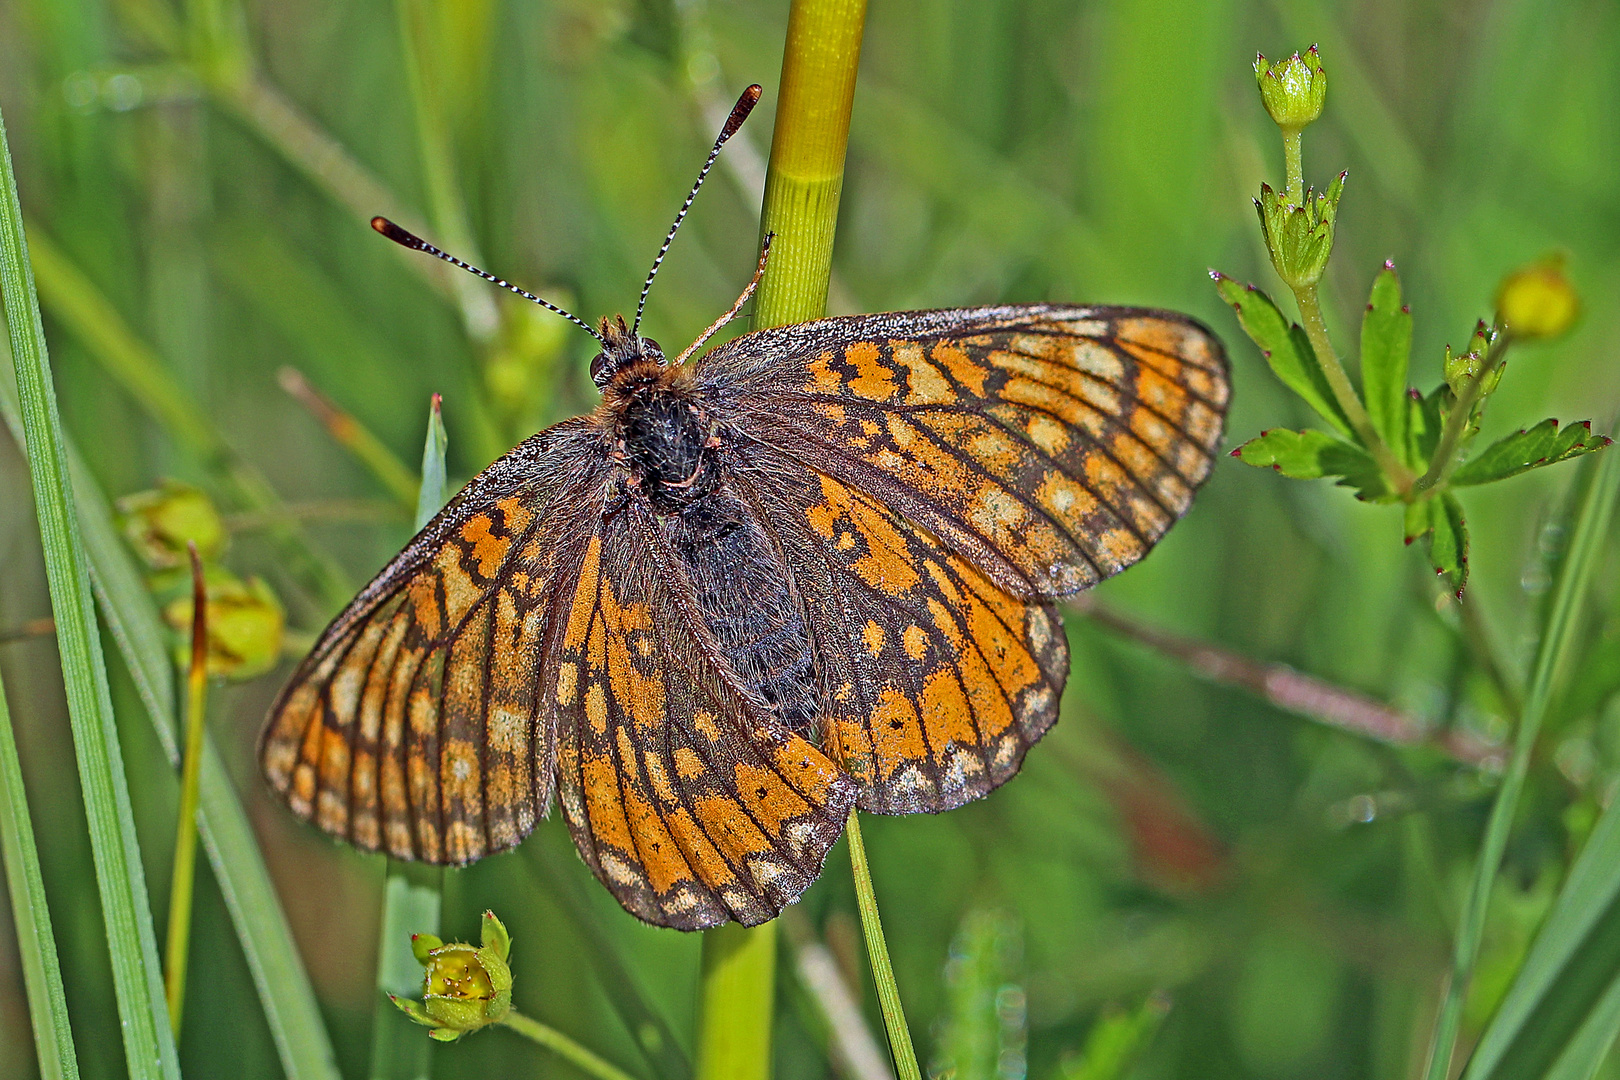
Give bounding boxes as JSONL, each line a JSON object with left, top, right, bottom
{"left": 1426, "top": 440, "right": 1620, "bottom": 1080}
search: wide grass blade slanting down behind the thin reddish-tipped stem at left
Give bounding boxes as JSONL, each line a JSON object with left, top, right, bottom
{"left": 0, "top": 325, "right": 337, "bottom": 1080}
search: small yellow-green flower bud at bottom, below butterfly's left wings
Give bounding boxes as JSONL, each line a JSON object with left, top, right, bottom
{"left": 389, "top": 912, "right": 512, "bottom": 1043}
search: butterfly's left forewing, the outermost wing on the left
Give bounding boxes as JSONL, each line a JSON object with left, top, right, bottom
{"left": 259, "top": 423, "right": 601, "bottom": 865}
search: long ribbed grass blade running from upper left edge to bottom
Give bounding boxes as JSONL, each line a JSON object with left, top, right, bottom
{"left": 0, "top": 95, "right": 180, "bottom": 1080}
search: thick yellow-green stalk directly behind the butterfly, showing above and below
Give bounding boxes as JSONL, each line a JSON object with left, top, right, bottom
{"left": 697, "top": 0, "right": 867, "bottom": 1080}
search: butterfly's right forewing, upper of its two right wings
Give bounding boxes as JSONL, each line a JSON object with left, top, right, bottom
{"left": 698, "top": 304, "right": 1230, "bottom": 597}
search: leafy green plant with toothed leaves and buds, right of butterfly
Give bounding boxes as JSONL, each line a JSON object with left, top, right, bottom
{"left": 1210, "top": 45, "right": 1610, "bottom": 596}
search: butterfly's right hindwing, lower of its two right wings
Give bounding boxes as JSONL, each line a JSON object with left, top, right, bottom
{"left": 737, "top": 447, "right": 1069, "bottom": 814}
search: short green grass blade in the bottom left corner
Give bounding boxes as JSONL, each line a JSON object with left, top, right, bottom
{"left": 0, "top": 667, "right": 79, "bottom": 1080}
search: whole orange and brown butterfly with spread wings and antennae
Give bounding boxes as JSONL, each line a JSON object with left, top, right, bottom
{"left": 261, "top": 87, "right": 1228, "bottom": 929}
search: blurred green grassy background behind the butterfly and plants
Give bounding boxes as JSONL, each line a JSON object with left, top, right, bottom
{"left": 0, "top": 0, "right": 1620, "bottom": 1080}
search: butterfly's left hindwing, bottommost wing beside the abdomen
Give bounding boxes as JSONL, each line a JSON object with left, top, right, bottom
{"left": 548, "top": 499, "right": 855, "bottom": 929}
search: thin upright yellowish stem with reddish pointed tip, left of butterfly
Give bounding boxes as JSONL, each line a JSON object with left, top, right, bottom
{"left": 164, "top": 544, "right": 207, "bottom": 1040}
